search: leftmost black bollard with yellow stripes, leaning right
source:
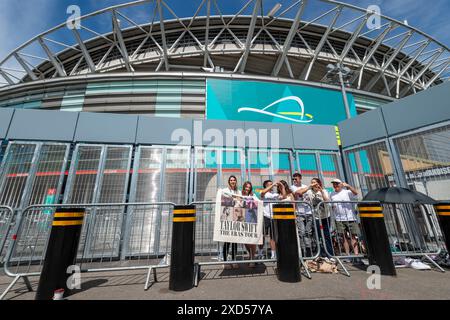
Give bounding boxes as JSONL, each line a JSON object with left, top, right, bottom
{"left": 35, "top": 208, "right": 85, "bottom": 300}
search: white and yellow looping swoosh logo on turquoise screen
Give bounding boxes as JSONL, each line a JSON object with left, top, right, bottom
{"left": 238, "top": 96, "right": 314, "bottom": 123}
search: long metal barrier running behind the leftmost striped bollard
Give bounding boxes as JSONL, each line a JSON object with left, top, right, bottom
{"left": 0, "top": 202, "right": 175, "bottom": 300}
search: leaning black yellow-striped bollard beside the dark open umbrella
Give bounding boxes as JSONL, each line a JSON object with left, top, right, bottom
{"left": 358, "top": 202, "right": 397, "bottom": 276}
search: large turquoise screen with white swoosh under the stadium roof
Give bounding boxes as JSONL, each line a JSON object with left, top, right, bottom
{"left": 206, "top": 79, "right": 356, "bottom": 125}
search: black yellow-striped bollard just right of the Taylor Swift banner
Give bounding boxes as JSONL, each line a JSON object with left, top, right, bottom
{"left": 272, "top": 204, "right": 301, "bottom": 283}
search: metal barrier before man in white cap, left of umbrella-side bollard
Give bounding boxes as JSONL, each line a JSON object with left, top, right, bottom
{"left": 315, "top": 201, "right": 370, "bottom": 276}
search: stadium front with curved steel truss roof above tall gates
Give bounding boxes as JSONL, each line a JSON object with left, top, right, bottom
{"left": 0, "top": 0, "right": 450, "bottom": 208}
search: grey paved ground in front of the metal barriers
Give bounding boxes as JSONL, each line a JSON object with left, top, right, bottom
{"left": 0, "top": 266, "right": 450, "bottom": 300}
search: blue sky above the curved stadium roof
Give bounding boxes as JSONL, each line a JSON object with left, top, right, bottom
{"left": 0, "top": 0, "right": 450, "bottom": 59}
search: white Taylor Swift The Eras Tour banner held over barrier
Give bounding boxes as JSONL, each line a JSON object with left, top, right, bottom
{"left": 213, "top": 190, "right": 264, "bottom": 244}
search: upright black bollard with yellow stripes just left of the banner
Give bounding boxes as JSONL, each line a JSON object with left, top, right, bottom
{"left": 169, "top": 206, "right": 195, "bottom": 291}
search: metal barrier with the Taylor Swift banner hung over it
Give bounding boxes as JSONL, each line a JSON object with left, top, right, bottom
{"left": 191, "top": 201, "right": 320, "bottom": 286}
